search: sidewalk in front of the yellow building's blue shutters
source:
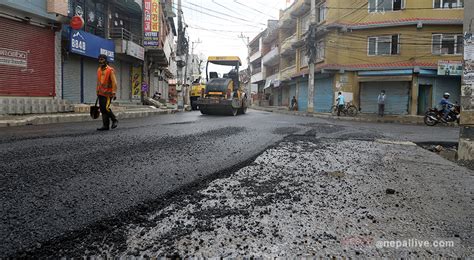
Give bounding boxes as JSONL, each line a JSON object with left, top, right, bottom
{"left": 251, "top": 105, "right": 424, "bottom": 125}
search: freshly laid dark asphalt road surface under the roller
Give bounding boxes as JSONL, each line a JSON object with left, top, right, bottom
{"left": 0, "top": 110, "right": 466, "bottom": 256}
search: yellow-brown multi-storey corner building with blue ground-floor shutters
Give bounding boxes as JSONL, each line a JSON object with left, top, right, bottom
{"left": 308, "top": 0, "right": 463, "bottom": 115}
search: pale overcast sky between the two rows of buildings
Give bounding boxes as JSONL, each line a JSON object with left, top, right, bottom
{"left": 174, "top": 0, "right": 293, "bottom": 68}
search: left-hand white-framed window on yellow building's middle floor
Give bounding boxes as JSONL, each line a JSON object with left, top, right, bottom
{"left": 368, "top": 34, "right": 400, "bottom": 56}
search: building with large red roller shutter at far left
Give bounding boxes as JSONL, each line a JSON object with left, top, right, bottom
{"left": 0, "top": 0, "right": 67, "bottom": 114}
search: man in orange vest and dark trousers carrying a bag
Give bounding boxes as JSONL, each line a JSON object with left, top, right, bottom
{"left": 96, "top": 54, "right": 118, "bottom": 131}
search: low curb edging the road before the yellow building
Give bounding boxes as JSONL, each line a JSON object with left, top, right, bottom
{"left": 250, "top": 106, "right": 424, "bottom": 125}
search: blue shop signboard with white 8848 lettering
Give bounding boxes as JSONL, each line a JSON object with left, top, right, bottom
{"left": 69, "top": 29, "right": 115, "bottom": 61}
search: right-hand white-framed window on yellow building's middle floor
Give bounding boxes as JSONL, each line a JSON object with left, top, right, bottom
{"left": 432, "top": 34, "right": 464, "bottom": 55}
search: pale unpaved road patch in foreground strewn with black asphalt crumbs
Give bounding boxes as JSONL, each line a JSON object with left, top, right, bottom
{"left": 82, "top": 136, "right": 474, "bottom": 258}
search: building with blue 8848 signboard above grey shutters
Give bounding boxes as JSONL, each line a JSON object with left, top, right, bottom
{"left": 61, "top": 0, "right": 145, "bottom": 103}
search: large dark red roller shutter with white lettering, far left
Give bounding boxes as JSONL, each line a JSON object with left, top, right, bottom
{"left": 0, "top": 17, "right": 56, "bottom": 97}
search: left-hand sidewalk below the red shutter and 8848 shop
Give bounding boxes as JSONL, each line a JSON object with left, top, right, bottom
{"left": 0, "top": 106, "right": 182, "bottom": 128}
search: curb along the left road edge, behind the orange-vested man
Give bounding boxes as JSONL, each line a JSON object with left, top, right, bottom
{"left": 0, "top": 109, "right": 182, "bottom": 128}
